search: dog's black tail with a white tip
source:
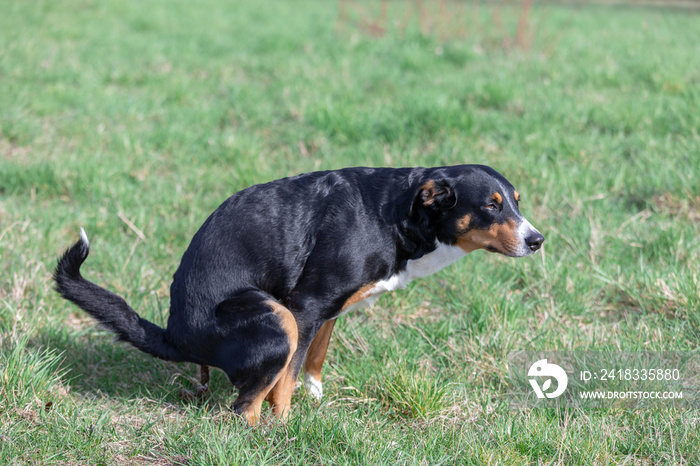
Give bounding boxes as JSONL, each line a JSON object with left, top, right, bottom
{"left": 53, "top": 228, "right": 185, "bottom": 361}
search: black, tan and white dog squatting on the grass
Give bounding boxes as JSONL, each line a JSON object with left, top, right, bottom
{"left": 54, "top": 165, "right": 544, "bottom": 425}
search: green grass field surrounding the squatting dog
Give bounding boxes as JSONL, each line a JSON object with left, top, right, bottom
{"left": 0, "top": 0, "right": 700, "bottom": 465}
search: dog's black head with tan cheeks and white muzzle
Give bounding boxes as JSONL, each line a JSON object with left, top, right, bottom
{"left": 409, "top": 165, "right": 544, "bottom": 257}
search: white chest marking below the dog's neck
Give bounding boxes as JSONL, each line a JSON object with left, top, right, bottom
{"left": 338, "top": 243, "right": 467, "bottom": 316}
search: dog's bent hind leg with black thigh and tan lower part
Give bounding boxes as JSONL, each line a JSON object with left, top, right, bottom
{"left": 216, "top": 291, "right": 298, "bottom": 425}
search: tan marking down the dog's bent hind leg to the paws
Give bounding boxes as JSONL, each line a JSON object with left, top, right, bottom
{"left": 242, "top": 300, "right": 299, "bottom": 426}
